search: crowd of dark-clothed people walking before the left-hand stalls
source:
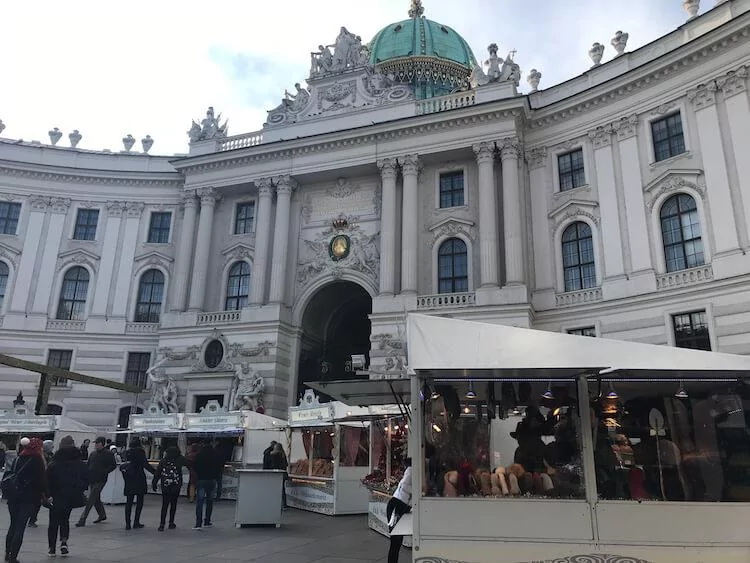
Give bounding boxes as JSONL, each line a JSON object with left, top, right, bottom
{"left": 0, "top": 436, "right": 229, "bottom": 563}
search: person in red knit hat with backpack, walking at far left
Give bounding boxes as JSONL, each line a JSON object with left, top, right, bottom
{"left": 3, "top": 438, "right": 47, "bottom": 563}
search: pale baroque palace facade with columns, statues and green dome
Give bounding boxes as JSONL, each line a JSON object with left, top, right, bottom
{"left": 0, "top": 0, "right": 750, "bottom": 427}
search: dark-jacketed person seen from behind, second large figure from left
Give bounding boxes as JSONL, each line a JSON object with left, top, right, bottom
{"left": 47, "top": 436, "right": 89, "bottom": 557}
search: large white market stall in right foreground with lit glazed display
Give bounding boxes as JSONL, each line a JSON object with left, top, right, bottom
{"left": 407, "top": 314, "right": 750, "bottom": 563}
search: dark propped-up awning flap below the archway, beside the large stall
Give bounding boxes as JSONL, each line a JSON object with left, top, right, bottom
{"left": 305, "top": 379, "right": 411, "bottom": 407}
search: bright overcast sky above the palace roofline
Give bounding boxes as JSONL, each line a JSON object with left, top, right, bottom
{"left": 0, "top": 0, "right": 714, "bottom": 157}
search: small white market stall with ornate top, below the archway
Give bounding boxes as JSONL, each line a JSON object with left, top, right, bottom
{"left": 286, "top": 389, "right": 370, "bottom": 515}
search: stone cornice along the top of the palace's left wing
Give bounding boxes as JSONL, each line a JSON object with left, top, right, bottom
{"left": 0, "top": 161, "right": 182, "bottom": 187}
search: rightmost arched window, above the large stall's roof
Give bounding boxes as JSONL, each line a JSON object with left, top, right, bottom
{"left": 659, "top": 194, "right": 704, "bottom": 272}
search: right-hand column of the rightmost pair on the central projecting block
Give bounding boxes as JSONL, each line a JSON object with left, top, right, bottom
{"left": 500, "top": 137, "right": 524, "bottom": 285}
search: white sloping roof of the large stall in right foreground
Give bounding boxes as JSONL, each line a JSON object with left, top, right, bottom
{"left": 407, "top": 314, "right": 750, "bottom": 378}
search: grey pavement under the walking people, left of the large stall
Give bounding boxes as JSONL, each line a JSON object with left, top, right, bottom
{"left": 0, "top": 495, "right": 411, "bottom": 563}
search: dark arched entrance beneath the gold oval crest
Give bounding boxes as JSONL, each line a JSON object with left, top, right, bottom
{"left": 297, "top": 281, "right": 372, "bottom": 399}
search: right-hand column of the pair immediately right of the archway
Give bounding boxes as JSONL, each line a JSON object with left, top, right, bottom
{"left": 400, "top": 154, "right": 419, "bottom": 293}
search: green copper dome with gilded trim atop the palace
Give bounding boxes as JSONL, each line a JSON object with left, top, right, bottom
{"left": 369, "top": 0, "right": 477, "bottom": 99}
